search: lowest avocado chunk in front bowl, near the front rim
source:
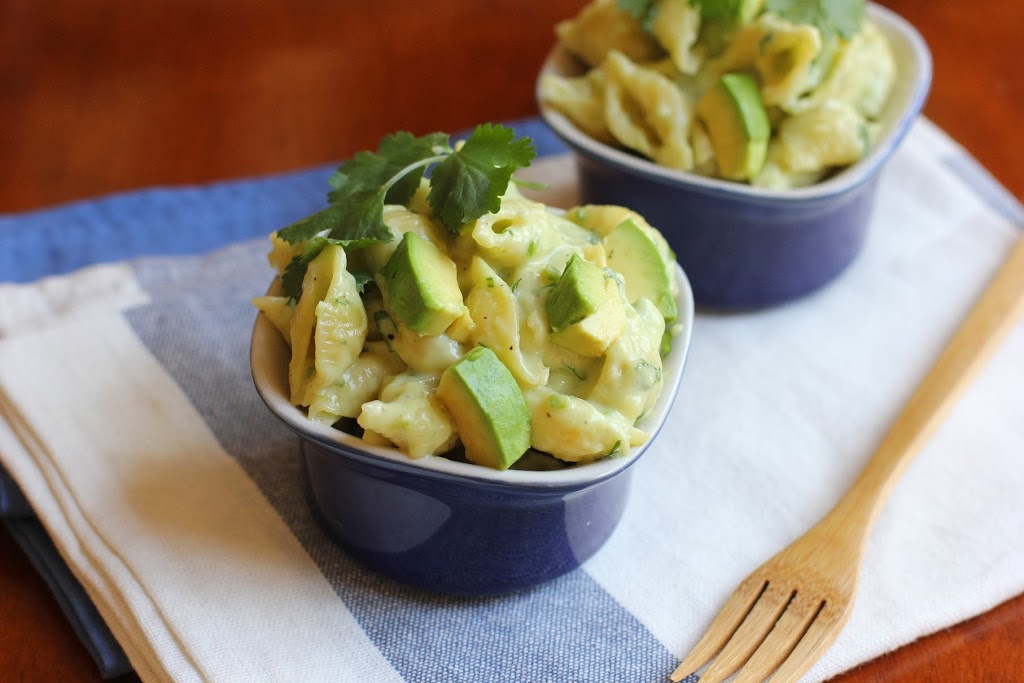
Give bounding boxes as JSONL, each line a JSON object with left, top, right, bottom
{"left": 437, "top": 346, "right": 530, "bottom": 470}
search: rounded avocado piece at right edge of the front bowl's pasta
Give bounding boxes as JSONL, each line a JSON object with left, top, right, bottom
{"left": 601, "top": 219, "right": 678, "bottom": 323}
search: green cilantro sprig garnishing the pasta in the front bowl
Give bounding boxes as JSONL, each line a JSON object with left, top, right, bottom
{"left": 276, "top": 124, "right": 537, "bottom": 299}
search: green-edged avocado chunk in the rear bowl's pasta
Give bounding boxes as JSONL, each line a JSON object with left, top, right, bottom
{"left": 696, "top": 74, "right": 771, "bottom": 180}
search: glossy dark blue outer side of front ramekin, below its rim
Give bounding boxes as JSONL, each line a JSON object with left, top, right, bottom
{"left": 303, "top": 441, "right": 632, "bottom": 596}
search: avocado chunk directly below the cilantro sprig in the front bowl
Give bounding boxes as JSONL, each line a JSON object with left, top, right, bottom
{"left": 381, "top": 232, "right": 465, "bottom": 337}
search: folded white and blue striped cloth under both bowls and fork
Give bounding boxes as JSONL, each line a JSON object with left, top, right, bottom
{"left": 0, "top": 120, "right": 1024, "bottom": 682}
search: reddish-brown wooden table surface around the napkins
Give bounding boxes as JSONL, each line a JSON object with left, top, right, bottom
{"left": 0, "top": 0, "right": 1024, "bottom": 683}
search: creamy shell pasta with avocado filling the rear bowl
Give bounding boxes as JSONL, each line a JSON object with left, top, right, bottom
{"left": 539, "top": 0, "right": 897, "bottom": 188}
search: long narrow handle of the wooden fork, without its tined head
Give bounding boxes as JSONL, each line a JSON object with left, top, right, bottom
{"left": 829, "top": 239, "right": 1024, "bottom": 530}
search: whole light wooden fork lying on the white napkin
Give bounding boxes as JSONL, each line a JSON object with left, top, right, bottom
{"left": 672, "top": 239, "right": 1024, "bottom": 683}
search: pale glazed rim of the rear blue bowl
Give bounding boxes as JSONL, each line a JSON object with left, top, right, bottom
{"left": 535, "top": 3, "right": 932, "bottom": 204}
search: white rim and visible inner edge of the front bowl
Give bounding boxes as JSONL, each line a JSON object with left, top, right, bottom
{"left": 250, "top": 266, "right": 693, "bottom": 487}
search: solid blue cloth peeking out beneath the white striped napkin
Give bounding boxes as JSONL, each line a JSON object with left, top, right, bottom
{"left": 0, "top": 119, "right": 565, "bottom": 679}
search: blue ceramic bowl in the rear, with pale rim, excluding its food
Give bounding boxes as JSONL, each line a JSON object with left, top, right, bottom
{"left": 537, "top": 4, "right": 932, "bottom": 310}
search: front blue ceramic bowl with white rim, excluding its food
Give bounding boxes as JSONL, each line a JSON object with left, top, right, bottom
{"left": 250, "top": 268, "right": 693, "bottom": 596}
